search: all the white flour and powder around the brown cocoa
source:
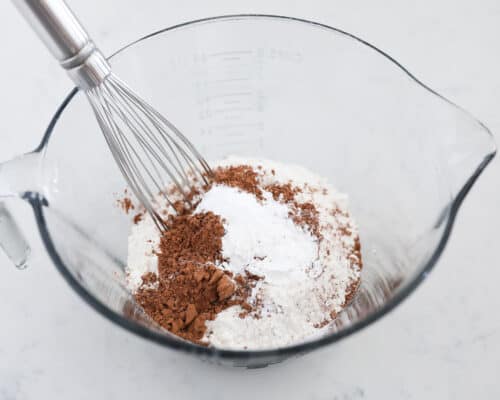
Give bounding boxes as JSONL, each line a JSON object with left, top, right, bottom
{"left": 124, "top": 157, "right": 361, "bottom": 349}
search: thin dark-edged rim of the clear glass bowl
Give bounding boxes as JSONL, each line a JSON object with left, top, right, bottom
{"left": 30, "top": 14, "right": 496, "bottom": 360}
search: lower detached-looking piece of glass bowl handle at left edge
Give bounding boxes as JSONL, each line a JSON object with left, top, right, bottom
{"left": 0, "top": 202, "right": 31, "bottom": 269}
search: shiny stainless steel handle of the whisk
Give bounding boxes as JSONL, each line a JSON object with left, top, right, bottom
{"left": 13, "top": 0, "right": 111, "bottom": 90}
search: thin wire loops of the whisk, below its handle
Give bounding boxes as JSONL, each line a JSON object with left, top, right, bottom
{"left": 86, "top": 74, "right": 212, "bottom": 229}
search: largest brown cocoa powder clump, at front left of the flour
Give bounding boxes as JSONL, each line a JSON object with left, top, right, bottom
{"left": 135, "top": 212, "right": 258, "bottom": 344}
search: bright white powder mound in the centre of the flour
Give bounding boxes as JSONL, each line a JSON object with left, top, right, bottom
{"left": 195, "top": 185, "right": 318, "bottom": 285}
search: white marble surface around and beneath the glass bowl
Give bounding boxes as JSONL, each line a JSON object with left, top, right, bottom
{"left": 0, "top": 0, "right": 500, "bottom": 400}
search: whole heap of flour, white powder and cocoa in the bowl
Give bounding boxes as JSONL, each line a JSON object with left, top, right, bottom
{"left": 127, "top": 157, "right": 362, "bottom": 349}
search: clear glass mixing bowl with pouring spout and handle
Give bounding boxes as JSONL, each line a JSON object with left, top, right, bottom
{"left": 0, "top": 15, "right": 496, "bottom": 367}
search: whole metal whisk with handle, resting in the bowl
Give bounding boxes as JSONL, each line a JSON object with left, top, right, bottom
{"left": 13, "top": 0, "right": 212, "bottom": 230}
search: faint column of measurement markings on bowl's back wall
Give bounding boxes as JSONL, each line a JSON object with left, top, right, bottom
{"left": 193, "top": 49, "right": 270, "bottom": 158}
